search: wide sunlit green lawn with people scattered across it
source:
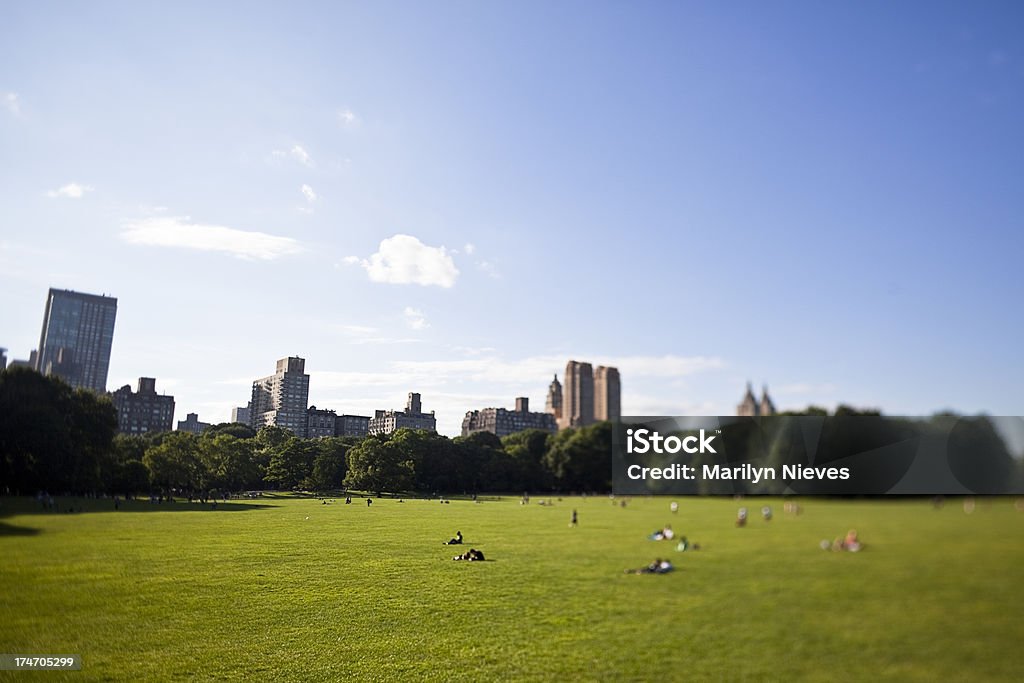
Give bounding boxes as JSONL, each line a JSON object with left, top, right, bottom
{"left": 0, "top": 497, "right": 1024, "bottom": 681}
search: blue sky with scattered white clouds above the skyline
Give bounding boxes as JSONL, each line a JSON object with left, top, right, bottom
{"left": 0, "top": 2, "right": 1024, "bottom": 434}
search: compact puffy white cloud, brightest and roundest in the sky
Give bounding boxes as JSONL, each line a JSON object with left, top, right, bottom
{"left": 360, "top": 234, "right": 459, "bottom": 288}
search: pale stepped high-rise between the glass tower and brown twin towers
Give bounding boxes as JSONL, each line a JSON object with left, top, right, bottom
{"left": 249, "top": 356, "right": 309, "bottom": 437}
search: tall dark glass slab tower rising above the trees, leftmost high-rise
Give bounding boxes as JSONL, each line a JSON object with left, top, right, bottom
{"left": 33, "top": 288, "right": 118, "bottom": 392}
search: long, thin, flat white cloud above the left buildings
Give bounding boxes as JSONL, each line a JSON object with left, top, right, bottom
{"left": 121, "top": 216, "right": 302, "bottom": 261}
